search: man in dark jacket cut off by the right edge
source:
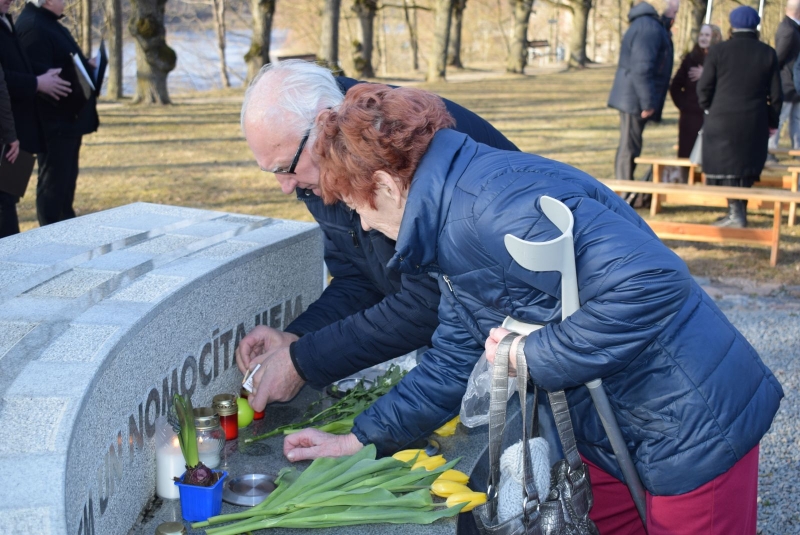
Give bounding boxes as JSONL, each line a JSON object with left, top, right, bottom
{"left": 769, "top": 0, "right": 800, "bottom": 154}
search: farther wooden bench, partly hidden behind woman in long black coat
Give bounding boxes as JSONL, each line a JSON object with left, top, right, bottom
{"left": 635, "top": 156, "right": 800, "bottom": 227}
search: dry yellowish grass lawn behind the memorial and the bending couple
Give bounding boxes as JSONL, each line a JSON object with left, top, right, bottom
{"left": 14, "top": 67, "right": 800, "bottom": 285}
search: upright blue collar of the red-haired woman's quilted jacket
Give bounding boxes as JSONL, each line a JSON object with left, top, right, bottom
{"left": 388, "top": 130, "right": 478, "bottom": 274}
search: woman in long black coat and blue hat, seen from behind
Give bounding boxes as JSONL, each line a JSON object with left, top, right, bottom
{"left": 697, "top": 6, "right": 783, "bottom": 228}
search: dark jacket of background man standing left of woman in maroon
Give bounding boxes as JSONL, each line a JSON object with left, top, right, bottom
{"left": 608, "top": 2, "right": 673, "bottom": 121}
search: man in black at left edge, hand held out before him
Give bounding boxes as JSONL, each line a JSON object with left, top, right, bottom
{"left": 0, "top": 0, "right": 70, "bottom": 238}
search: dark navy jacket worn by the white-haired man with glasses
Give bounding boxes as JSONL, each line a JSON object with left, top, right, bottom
{"left": 285, "top": 77, "right": 518, "bottom": 388}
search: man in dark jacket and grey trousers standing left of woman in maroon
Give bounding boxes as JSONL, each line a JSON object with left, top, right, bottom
{"left": 608, "top": 2, "right": 677, "bottom": 180}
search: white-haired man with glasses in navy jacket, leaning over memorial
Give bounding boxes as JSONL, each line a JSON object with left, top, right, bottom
{"left": 236, "top": 60, "right": 517, "bottom": 410}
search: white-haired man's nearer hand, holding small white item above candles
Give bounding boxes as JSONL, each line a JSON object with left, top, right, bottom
{"left": 247, "top": 347, "right": 305, "bottom": 412}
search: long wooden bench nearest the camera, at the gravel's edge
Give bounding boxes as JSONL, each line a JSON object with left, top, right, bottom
{"left": 601, "top": 180, "right": 800, "bottom": 267}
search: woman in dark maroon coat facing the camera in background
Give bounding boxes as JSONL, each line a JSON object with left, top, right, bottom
{"left": 669, "top": 24, "right": 722, "bottom": 158}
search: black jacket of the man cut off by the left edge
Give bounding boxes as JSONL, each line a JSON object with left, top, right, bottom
{"left": 0, "top": 15, "right": 44, "bottom": 154}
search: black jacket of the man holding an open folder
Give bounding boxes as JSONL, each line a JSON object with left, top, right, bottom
{"left": 17, "top": 3, "right": 100, "bottom": 137}
